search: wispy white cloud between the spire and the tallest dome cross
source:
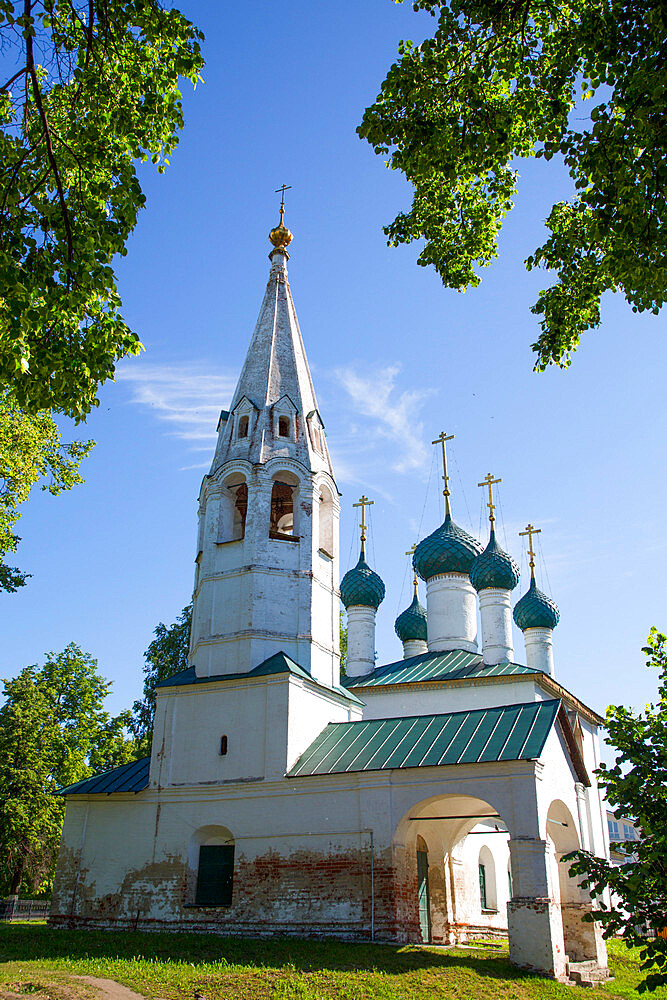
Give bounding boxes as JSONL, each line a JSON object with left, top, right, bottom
{"left": 334, "top": 365, "right": 433, "bottom": 473}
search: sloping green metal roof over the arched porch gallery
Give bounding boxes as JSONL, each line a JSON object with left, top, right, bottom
{"left": 288, "top": 700, "right": 561, "bottom": 778}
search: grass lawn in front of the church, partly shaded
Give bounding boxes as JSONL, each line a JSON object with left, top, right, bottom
{"left": 0, "top": 924, "right": 667, "bottom": 1000}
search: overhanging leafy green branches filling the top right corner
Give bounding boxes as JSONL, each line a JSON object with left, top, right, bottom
{"left": 358, "top": 0, "right": 667, "bottom": 370}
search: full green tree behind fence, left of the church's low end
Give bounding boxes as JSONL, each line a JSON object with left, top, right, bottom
{"left": 0, "top": 643, "right": 136, "bottom": 893}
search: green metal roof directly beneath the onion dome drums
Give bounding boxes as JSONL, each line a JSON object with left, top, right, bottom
{"left": 342, "top": 649, "right": 539, "bottom": 688}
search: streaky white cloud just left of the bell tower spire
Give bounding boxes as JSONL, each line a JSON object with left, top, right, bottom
{"left": 116, "top": 361, "right": 237, "bottom": 456}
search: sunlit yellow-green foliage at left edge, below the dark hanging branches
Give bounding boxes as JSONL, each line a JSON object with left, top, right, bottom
{"left": 0, "top": 391, "right": 94, "bottom": 591}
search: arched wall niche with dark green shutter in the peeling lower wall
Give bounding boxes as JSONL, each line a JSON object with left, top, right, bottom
{"left": 188, "top": 826, "right": 234, "bottom": 906}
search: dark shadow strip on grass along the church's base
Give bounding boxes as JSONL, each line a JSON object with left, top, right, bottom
{"left": 0, "top": 924, "right": 528, "bottom": 980}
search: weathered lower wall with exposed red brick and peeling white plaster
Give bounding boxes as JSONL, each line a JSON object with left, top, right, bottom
{"left": 51, "top": 848, "right": 421, "bottom": 942}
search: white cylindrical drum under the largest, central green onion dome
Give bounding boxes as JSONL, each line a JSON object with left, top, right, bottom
{"left": 426, "top": 573, "right": 477, "bottom": 653}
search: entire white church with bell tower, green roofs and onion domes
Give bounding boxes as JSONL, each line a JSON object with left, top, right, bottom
{"left": 50, "top": 211, "right": 608, "bottom": 979}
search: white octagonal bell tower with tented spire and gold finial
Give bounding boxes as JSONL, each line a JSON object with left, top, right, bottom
{"left": 190, "top": 207, "right": 340, "bottom": 686}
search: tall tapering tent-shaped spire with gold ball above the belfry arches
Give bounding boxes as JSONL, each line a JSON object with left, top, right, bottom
{"left": 211, "top": 222, "right": 333, "bottom": 476}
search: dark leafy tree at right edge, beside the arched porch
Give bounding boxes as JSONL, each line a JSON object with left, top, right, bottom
{"left": 564, "top": 628, "right": 667, "bottom": 992}
